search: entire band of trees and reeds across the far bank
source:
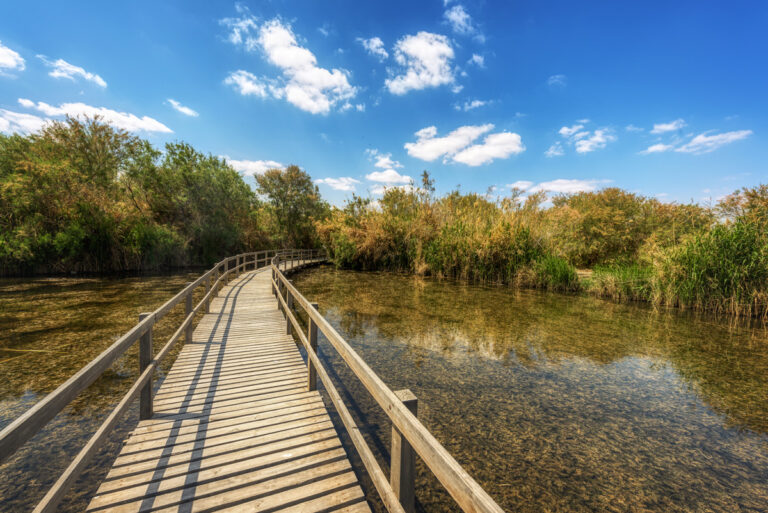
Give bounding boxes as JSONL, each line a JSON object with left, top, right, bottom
{"left": 0, "top": 119, "right": 768, "bottom": 317}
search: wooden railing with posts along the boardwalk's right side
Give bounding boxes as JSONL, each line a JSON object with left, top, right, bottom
{"left": 272, "top": 252, "right": 503, "bottom": 513}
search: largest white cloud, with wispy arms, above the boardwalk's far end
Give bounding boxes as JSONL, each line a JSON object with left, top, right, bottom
{"left": 222, "top": 15, "right": 357, "bottom": 114}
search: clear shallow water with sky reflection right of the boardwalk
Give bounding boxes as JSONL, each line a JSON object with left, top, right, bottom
{"left": 294, "top": 267, "right": 768, "bottom": 512}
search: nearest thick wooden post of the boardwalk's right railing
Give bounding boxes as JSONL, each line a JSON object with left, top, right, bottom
{"left": 389, "top": 389, "right": 418, "bottom": 513}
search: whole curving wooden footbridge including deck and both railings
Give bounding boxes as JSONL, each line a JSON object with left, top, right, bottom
{"left": 0, "top": 250, "right": 502, "bottom": 513}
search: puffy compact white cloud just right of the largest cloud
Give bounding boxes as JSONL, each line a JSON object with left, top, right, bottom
{"left": 385, "top": 32, "right": 455, "bottom": 95}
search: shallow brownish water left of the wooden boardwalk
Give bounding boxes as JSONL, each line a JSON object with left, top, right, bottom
{"left": 0, "top": 273, "right": 202, "bottom": 511}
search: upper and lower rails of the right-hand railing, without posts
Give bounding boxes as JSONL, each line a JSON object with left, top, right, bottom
{"left": 272, "top": 251, "right": 503, "bottom": 513}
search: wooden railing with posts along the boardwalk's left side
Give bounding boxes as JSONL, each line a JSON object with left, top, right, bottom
{"left": 0, "top": 250, "right": 320, "bottom": 512}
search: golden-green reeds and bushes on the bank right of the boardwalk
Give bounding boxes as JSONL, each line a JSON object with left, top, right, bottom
{"left": 318, "top": 172, "right": 768, "bottom": 317}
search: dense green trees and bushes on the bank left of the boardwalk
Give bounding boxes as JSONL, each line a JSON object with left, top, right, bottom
{"left": 0, "top": 119, "right": 328, "bottom": 274}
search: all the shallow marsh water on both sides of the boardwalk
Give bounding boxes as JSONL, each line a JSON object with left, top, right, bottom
{"left": 0, "top": 267, "right": 768, "bottom": 512}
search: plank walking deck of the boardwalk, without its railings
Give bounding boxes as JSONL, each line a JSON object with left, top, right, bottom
{"left": 88, "top": 269, "right": 370, "bottom": 512}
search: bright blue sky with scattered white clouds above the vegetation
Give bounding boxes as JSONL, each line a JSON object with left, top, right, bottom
{"left": 0, "top": 0, "right": 768, "bottom": 204}
